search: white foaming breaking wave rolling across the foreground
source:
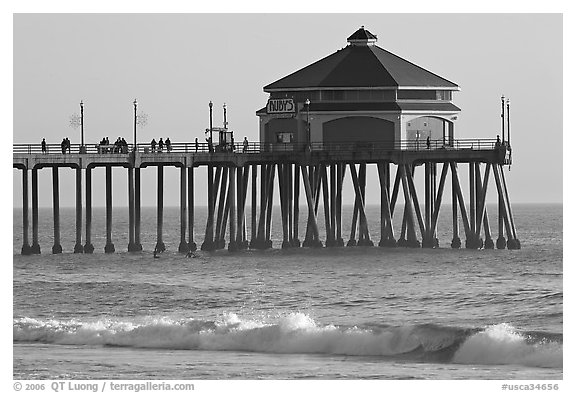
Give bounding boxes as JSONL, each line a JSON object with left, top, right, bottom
{"left": 13, "top": 313, "right": 562, "bottom": 368}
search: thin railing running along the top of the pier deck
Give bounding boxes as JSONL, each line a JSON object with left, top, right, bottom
{"left": 12, "top": 139, "right": 505, "bottom": 154}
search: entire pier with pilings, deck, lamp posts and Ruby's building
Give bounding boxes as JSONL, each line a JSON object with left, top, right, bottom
{"left": 13, "top": 27, "right": 520, "bottom": 254}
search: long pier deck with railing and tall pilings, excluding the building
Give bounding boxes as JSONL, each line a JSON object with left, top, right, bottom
{"left": 13, "top": 140, "right": 520, "bottom": 255}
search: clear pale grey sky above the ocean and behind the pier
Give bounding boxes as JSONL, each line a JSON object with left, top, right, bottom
{"left": 12, "top": 13, "right": 563, "bottom": 207}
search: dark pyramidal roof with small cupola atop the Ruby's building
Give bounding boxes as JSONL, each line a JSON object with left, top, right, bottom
{"left": 264, "top": 26, "right": 459, "bottom": 91}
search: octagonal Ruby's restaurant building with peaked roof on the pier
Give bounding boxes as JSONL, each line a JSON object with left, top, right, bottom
{"left": 256, "top": 26, "right": 460, "bottom": 150}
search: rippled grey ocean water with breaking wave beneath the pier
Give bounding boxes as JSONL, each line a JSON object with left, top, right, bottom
{"left": 13, "top": 205, "right": 563, "bottom": 380}
